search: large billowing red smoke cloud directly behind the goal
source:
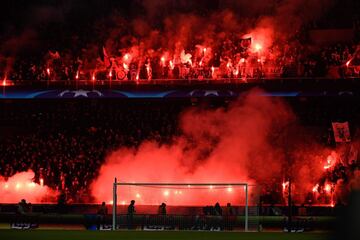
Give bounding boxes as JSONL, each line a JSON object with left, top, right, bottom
{"left": 92, "top": 91, "right": 324, "bottom": 205}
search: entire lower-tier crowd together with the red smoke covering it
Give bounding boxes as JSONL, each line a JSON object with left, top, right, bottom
{"left": 0, "top": 91, "right": 359, "bottom": 205}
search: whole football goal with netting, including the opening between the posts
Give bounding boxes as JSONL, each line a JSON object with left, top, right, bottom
{"left": 112, "top": 179, "right": 258, "bottom": 231}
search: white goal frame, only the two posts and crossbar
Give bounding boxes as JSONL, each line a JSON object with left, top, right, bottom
{"left": 112, "top": 178, "right": 249, "bottom": 232}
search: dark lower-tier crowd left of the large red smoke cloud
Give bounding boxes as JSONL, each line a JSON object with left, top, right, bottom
{"left": 0, "top": 101, "right": 181, "bottom": 202}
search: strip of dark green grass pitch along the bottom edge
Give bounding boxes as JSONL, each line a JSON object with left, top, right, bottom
{"left": 0, "top": 230, "right": 327, "bottom": 240}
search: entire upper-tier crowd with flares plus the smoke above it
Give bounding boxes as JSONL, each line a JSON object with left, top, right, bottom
{"left": 0, "top": 0, "right": 359, "bottom": 83}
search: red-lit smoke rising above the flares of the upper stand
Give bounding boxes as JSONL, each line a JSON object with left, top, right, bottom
{"left": 82, "top": 0, "right": 333, "bottom": 75}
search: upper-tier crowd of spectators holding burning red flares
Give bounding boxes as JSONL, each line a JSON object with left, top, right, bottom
{"left": 0, "top": 40, "right": 360, "bottom": 83}
